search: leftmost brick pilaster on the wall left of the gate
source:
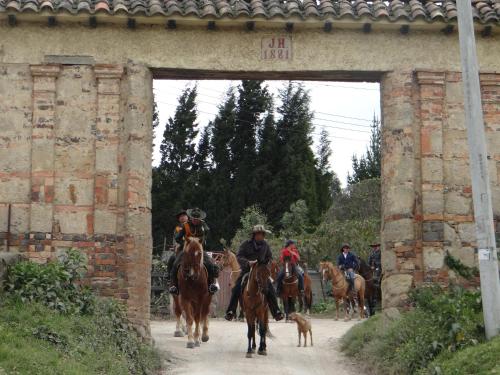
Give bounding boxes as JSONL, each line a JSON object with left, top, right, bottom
{"left": 29, "top": 65, "right": 61, "bottom": 262}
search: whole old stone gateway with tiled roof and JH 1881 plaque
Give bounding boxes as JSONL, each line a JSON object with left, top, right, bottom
{"left": 0, "top": 0, "right": 500, "bottom": 335}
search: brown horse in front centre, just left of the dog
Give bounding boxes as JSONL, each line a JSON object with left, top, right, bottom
{"left": 242, "top": 262, "right": 271, "bottom": 358}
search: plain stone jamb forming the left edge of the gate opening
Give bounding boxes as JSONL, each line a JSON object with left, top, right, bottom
{"left": 122, "top": 65, "right": 153, "bottom": 336}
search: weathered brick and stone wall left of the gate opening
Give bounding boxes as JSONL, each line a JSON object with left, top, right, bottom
{"left": 0, "top": 64, "right": 152, "bottom": 335}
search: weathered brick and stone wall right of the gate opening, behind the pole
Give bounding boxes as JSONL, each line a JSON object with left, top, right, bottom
{"left": 382, "top": 71, "right": 500, "bottom": 307}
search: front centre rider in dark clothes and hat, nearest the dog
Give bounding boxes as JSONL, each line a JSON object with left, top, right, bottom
{"left": 225, "top": 225, "right": 283, "bottom": 321}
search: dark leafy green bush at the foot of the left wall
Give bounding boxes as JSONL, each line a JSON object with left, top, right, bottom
{"left": 5, "top": 250, "right": 94, "bottom": 314}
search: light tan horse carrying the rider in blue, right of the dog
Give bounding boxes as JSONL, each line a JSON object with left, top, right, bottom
{"left": 320, "top": 262, "right": 365, "bottom": 321}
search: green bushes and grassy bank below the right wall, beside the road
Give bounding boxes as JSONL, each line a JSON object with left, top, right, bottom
{"left": 342, "top": 286, "right": 483, "bottom": 374}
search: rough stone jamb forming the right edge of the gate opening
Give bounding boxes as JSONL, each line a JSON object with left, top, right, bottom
{"left": 381, "top": 71, "right": 421, "bottom": 308}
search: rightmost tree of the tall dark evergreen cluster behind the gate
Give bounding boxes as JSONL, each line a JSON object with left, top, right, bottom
{"left": 275, "top": 83, "right": 319, "bottom": 220}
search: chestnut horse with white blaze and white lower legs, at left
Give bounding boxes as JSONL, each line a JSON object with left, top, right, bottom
{"left": 178, "top": 237, "right": 212, "bottom": 349}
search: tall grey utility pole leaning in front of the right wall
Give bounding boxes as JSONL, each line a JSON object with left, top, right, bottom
{"left": 457, "top": 0, "right": 500, "bottom": 339}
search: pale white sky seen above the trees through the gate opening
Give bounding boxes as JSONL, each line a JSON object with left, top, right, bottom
{"left": 153, "top": 80, "right": 380, "bottom": 186}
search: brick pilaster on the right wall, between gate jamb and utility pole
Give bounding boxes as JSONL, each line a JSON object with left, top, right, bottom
{"left": 416, "top": 71, "right": 447, "bottom": 281}
